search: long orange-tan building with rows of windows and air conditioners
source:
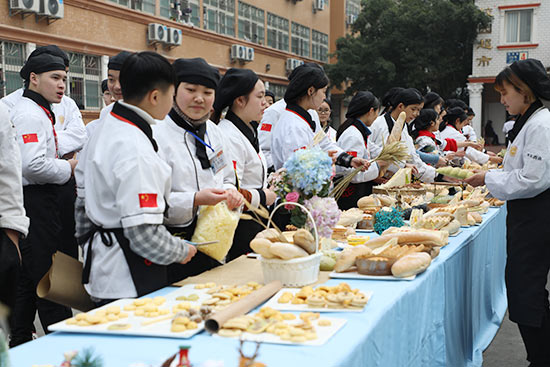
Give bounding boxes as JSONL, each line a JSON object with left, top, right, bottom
{"left": 0, "top": 0, "right": 360, "bottom": 121}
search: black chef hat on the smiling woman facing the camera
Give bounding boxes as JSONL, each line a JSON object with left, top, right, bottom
{"left": 172, "top": 57, "right": 220, "bottom": 89}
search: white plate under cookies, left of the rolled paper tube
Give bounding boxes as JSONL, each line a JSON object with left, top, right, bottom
{"left": 49, "top": 284, "right": 220, "bottom": 339}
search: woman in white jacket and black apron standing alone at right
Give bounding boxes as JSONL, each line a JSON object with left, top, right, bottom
{"left": 465, "top": 59, "right": 550, "bottom": 367}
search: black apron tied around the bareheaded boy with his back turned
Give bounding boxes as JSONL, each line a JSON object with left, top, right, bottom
{"left": 78, "top": 226, "right": 168, "bottom": 297}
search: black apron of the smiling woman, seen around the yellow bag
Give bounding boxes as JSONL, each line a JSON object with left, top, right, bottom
{"left": 166, "top": 217, "right": 221, "bottom": 284}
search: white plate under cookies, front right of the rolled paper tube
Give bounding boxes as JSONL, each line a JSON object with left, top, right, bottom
{"left": 214, "top": 316, "right": 347, "bottom": 346}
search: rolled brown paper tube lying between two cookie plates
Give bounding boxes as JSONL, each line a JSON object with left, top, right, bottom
{"left": 204, "top": 280, "right": 283, "bottom": 334}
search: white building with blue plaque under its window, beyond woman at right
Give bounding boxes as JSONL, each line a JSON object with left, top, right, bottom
{"left": 468, "top": 0, "right": 550, "bottom": 143}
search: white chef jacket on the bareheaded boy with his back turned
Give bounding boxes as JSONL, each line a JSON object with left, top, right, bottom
{"left": 83, "top": 104, "right": 171, "bottom": 299}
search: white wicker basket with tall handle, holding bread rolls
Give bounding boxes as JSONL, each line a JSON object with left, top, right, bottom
{"left": 260, "top": 203, "right": 321, "bottom": 287}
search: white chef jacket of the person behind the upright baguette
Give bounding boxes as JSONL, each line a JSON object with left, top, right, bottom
{"left": 369, "top": 115, "right": 437, "bottom": 182}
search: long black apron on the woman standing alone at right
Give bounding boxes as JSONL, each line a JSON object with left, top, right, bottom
{"left": 505, "top": 189, "right": 550, "bottom": 327}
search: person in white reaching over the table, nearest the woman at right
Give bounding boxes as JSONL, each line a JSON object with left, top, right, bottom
{"left": 440, "top": 107, "right": 502, "bottom": 165}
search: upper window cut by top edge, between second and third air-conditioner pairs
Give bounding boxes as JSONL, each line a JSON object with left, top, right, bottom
{"left": 202, "top": 0, "right": 235, "bottom": 37}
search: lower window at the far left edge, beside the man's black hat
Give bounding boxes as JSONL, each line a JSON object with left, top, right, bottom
{"left": 0, "top": 41, "right": 26, "bottom": 97}
